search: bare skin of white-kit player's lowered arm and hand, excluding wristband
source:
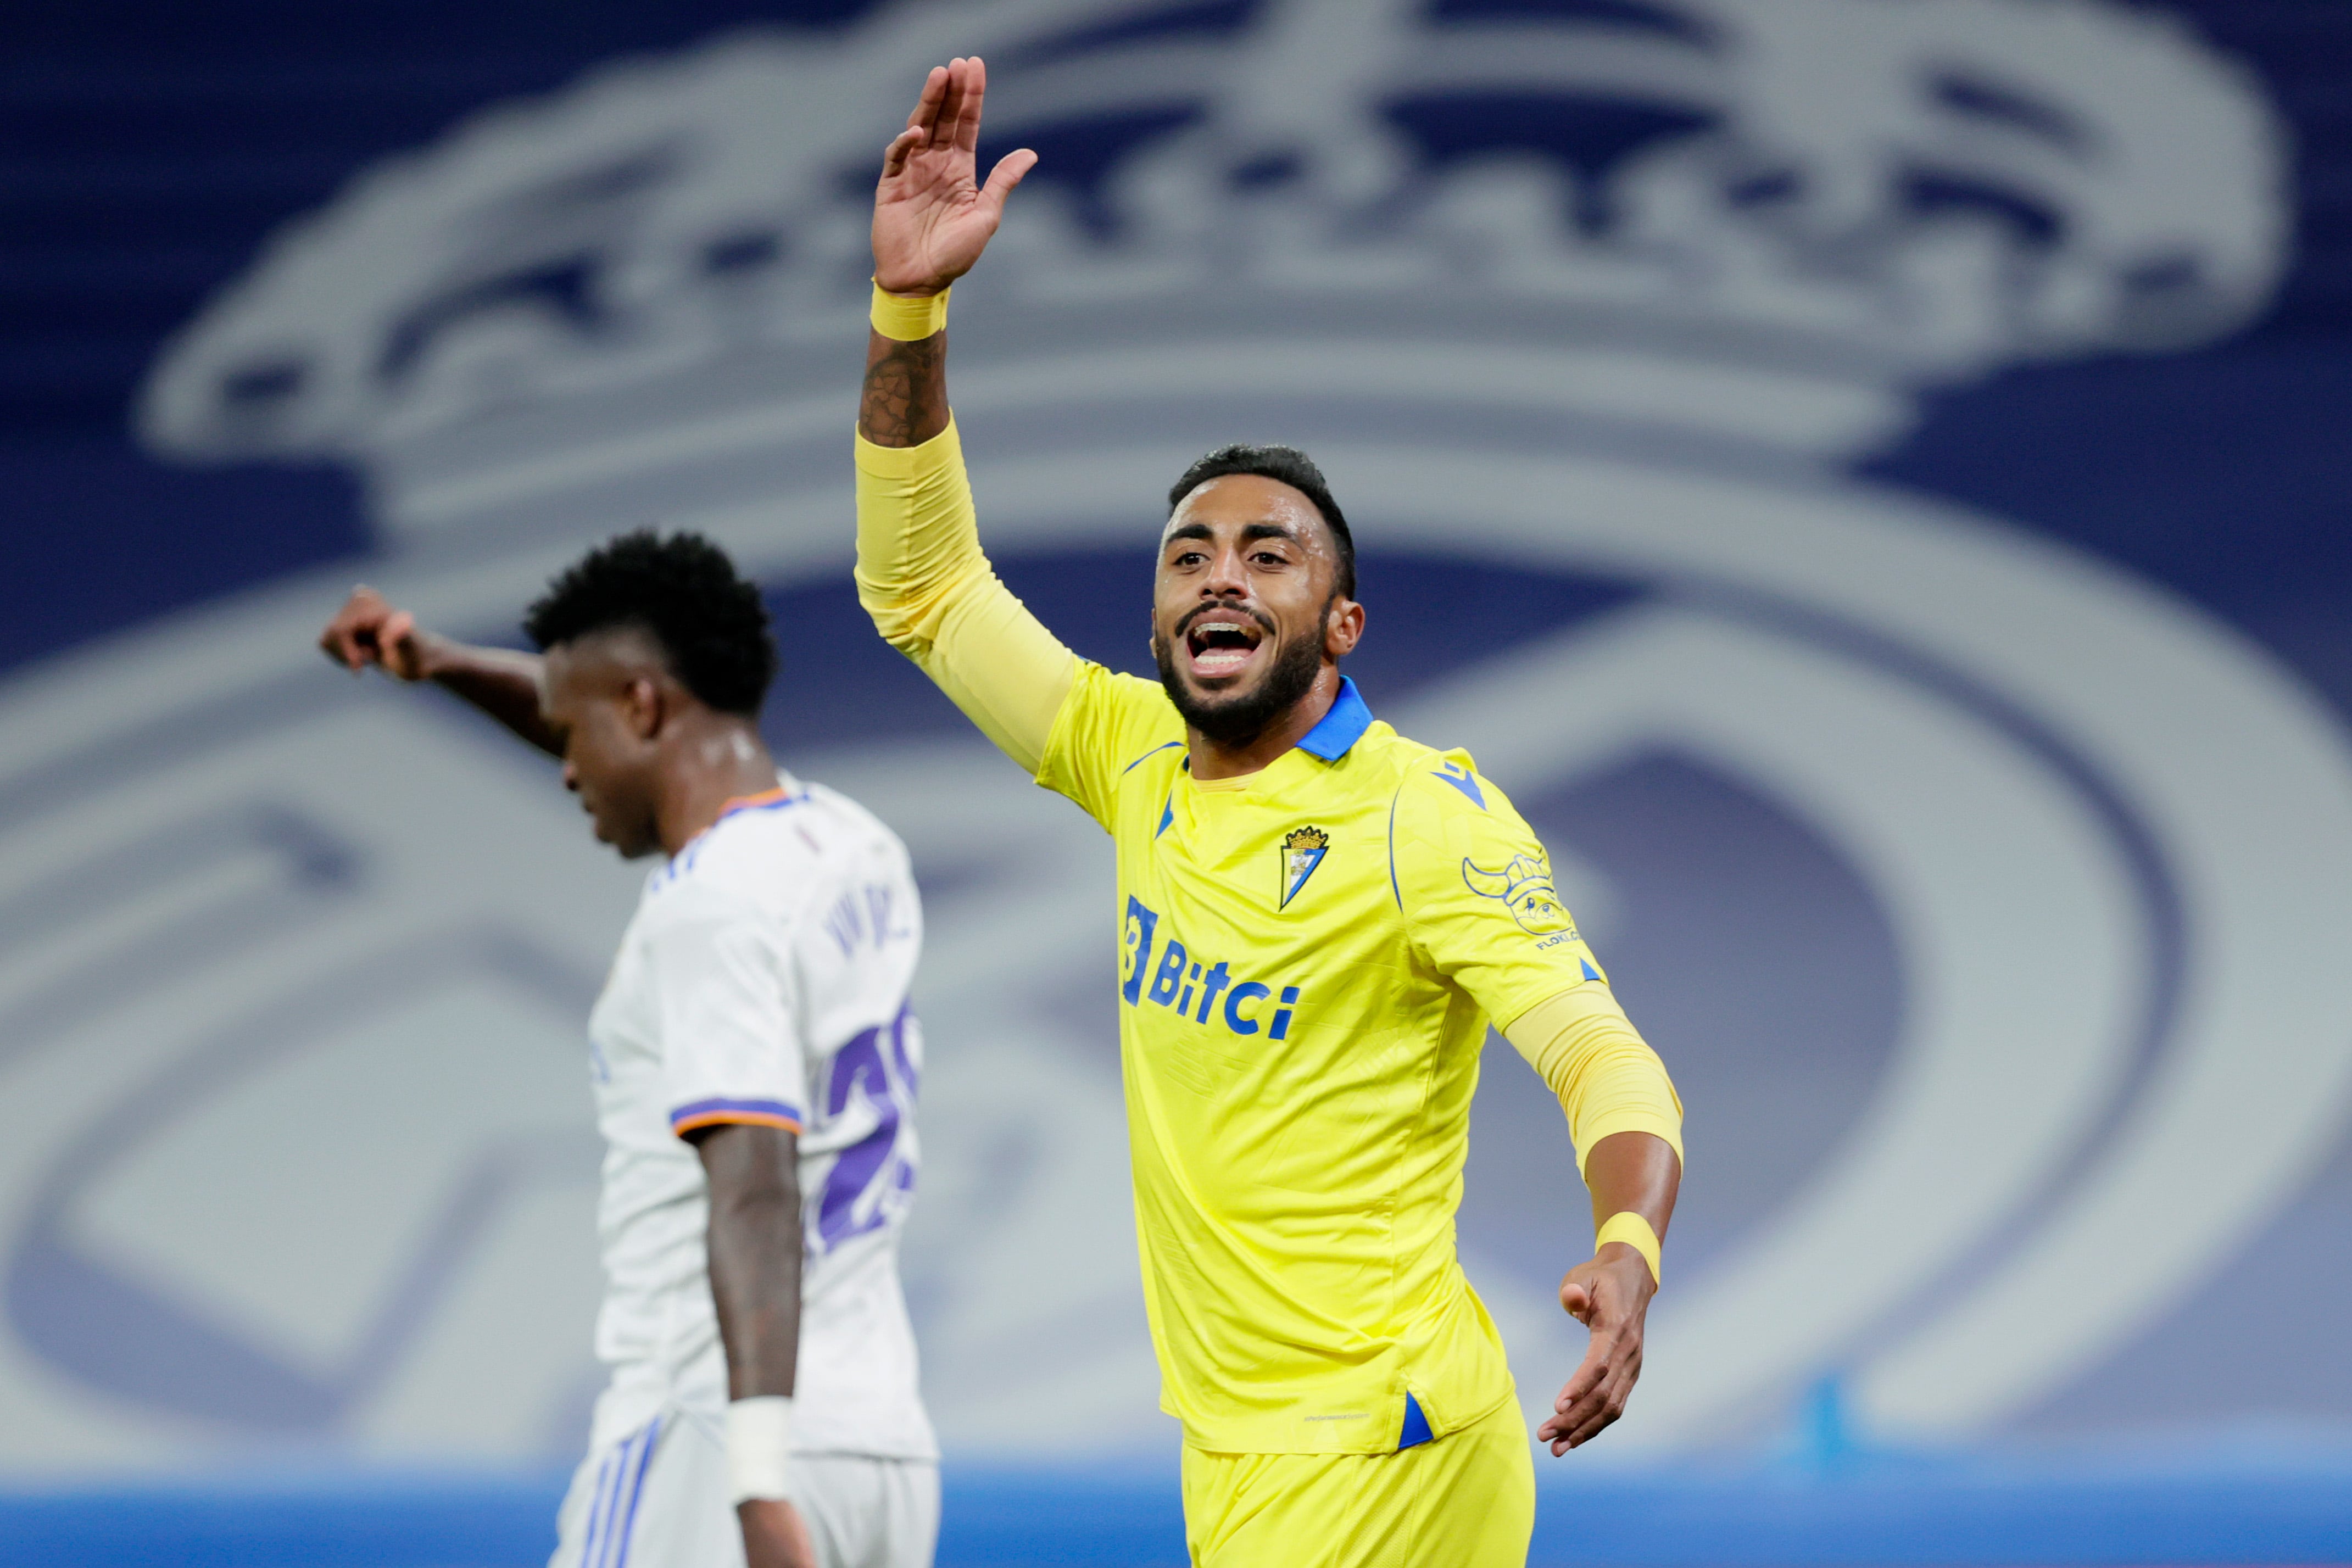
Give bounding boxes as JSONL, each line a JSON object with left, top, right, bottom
{"left": 689, "top": 1121, "right": 816, "bottom": 1568}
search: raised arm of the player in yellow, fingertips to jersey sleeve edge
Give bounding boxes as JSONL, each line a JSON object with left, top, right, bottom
{"left": 856, "top": 59, "right": 1077, "bottom": 773}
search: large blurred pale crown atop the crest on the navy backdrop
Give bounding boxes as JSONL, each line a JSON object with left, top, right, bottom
{"left": 141, "top": 0, "right": 2291, "bottom": 484}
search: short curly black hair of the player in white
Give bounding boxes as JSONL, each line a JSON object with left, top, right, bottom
{"left": 522, "top": 529, "right": 776, "bottom": 715}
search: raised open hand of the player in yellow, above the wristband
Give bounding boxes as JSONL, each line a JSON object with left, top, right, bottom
{"left": 875, "top": 59, "right": 1037, "bottom": 294}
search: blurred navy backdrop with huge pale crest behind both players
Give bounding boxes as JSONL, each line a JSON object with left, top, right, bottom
{"left": 0, "top": 0, "right": 2352, "bottom": 1465}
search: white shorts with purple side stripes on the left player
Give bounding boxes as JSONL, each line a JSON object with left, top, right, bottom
{"left": 548, "top": 1410, "right": 939, "bottom": 1568}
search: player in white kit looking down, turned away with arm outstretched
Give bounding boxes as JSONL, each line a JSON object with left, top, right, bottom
{"left": 320, "top": 534, "right": 939, "bottom": 1568}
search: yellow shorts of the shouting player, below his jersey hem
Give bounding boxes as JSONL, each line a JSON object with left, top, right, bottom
{"left": 1183, "top": 1399, "right": 1536, "bottom": 1568}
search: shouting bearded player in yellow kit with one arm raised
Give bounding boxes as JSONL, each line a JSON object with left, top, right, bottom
{"left": 856, "top": 59, "right": 1682, "bottom": 1568}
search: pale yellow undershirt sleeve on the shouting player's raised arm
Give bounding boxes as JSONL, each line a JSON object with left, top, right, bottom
{"left": 856, "top": 421, "right": 1077, "bottom": 773}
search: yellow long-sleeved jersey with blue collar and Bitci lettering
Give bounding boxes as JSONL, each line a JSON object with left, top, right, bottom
{"left": 859, "top": 426, "right": 1682, "bottom": 1453}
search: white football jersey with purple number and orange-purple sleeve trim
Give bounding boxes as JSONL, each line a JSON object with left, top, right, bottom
{"left": 588, "top": 776, "right": 939, "bottom": 1460}
